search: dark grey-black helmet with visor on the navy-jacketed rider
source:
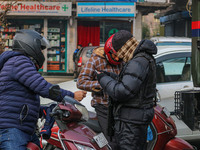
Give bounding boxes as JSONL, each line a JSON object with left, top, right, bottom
{"left": 12, "top": 29, "right": 50, "bottom": 68}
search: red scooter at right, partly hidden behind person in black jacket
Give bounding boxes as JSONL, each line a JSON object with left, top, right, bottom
{"left": 147, "top": 105, "right": 195, "bottom": 150}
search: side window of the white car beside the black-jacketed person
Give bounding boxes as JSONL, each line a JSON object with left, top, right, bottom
{"left": 156, "top": 57, "right": 191, "bottom": 83}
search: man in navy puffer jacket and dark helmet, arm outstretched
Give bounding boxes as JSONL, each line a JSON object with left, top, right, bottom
{"left": 0, "top": 30, "right": 86, "bottom": 150}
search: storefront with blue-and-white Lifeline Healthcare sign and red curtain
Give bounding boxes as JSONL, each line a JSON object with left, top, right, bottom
{"left": 77, "top": 0, "right": 136, "bottom": 46}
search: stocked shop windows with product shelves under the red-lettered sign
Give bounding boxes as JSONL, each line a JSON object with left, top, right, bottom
{"left": 0, "top": 19, "right": 67, "bottom": 72}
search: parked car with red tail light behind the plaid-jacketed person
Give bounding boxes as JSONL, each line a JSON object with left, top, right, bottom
{"left": 74, "top": 46, "right": 98, "bottom": 79}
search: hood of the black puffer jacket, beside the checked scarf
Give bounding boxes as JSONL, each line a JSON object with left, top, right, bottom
{"left": 133, "top": 40, "right": 157, "bottom": 56}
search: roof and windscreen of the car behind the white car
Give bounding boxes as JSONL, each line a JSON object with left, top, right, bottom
{"left": 150, "top": 36, "right": 192, "bottom": 46}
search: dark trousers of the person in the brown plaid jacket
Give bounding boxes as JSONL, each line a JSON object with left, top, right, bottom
{"left": 94, "top": 104, "right": 120, "bottom": 150}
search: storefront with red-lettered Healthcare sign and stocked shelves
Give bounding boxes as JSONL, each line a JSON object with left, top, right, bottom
{"left": 0, "top": 1, "right": 72, "bottom": 72}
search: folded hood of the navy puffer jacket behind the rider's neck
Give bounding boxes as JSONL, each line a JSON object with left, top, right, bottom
{"left": 0, "top": 51, "right": 23, "bottom": 70}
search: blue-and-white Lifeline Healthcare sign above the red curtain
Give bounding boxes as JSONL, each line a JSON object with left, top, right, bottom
{"left": 77, "top": 2, "right": 135, "bottom": 17}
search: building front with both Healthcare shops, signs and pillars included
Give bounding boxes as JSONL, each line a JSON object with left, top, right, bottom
{"left": 0, "top": 0, "right": 171, "bottom": 74}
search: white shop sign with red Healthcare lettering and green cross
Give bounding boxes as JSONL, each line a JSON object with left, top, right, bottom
{"left": 0, "top": 1, "right": 72, "bottom": 16}
